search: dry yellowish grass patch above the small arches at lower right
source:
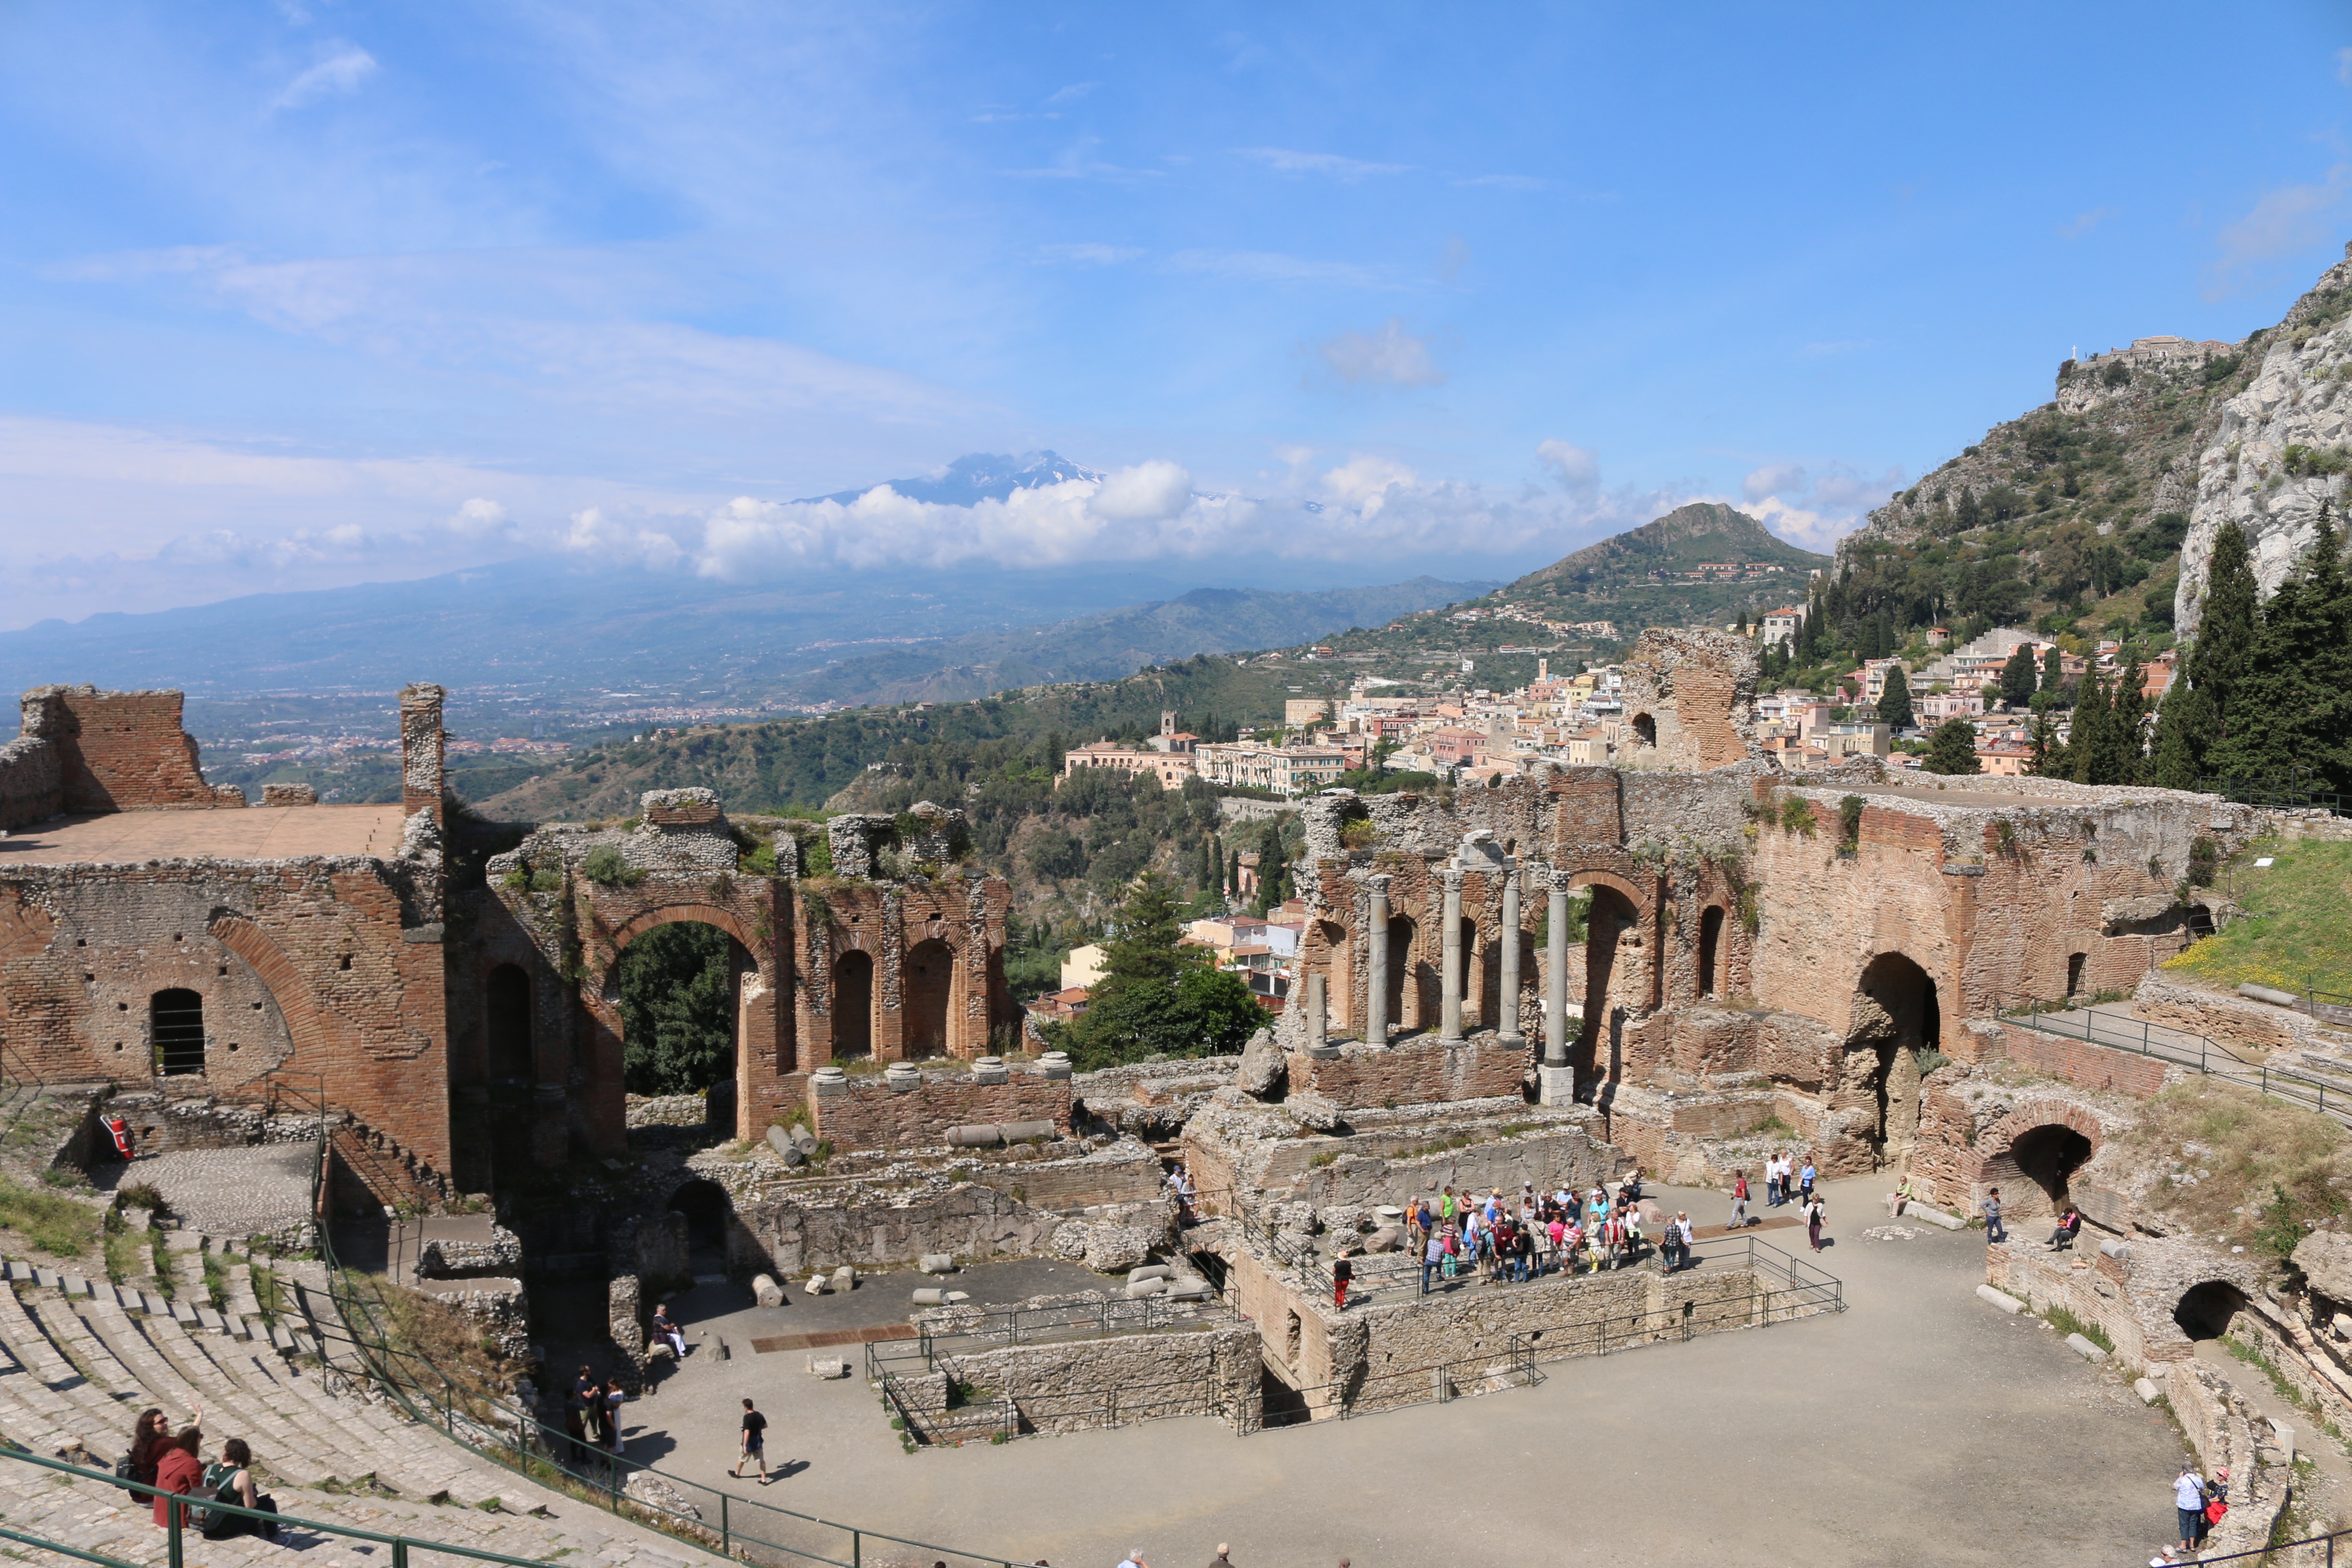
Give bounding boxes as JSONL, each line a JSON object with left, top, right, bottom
{"left": 2122, "top": 1079, "right": 2352, "bottom": 1253}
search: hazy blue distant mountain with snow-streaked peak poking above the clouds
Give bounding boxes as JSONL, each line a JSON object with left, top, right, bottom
{"left": 0, "top": 451, "right": 1491, "bottom": 733}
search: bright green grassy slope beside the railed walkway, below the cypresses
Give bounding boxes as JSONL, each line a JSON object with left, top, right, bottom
{"left": 2164, "top": 839, "right": 2352, "bottom": 994}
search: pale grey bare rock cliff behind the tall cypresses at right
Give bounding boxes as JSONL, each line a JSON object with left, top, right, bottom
{"left": 2173, "top": 245, "right": 2352, "bottom": 632}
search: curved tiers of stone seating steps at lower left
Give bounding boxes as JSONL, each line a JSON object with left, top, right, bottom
{"left": 0, "top": 1232, "right": 706, "bottom": 1568}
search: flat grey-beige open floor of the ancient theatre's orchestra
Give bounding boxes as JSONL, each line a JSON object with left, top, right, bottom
{"left": 602, "top": 1180, "right": 2180, "bottom": 1568}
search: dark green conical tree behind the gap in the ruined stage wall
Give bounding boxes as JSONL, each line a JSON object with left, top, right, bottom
{"left": 1063, "top": 872, "right": 1265, "bottom": 1072}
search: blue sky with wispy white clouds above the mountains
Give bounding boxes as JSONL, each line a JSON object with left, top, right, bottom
{"left": 0, "top": 0, "right": 2352, "bottom": 625}
